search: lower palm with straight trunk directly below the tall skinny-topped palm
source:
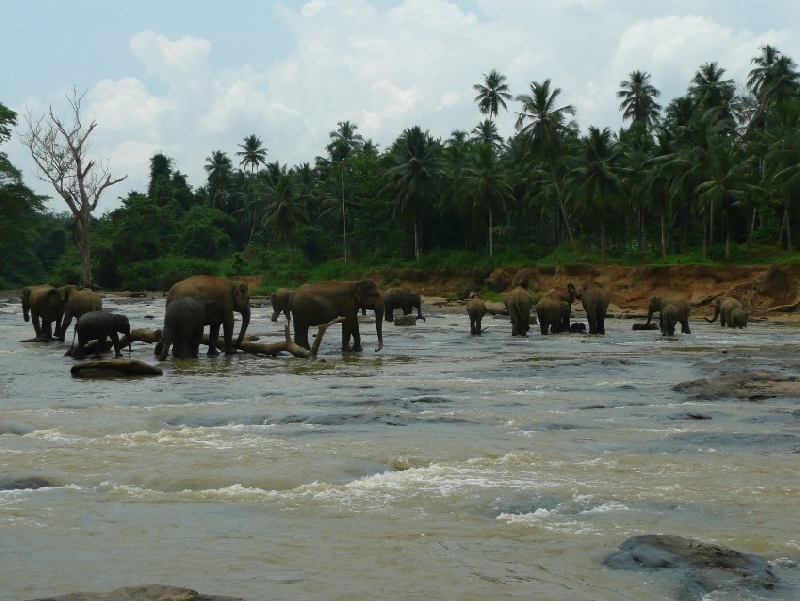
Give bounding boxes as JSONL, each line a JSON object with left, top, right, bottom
{"left": 457, "top": 143, "right": 513, "bottom": 257}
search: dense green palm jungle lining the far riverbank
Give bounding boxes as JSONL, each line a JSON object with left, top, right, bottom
{"left": 0, "top": 46, "right": 800, "bottom": 290}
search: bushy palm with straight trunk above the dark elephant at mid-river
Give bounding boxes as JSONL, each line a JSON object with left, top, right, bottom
{"left": 386, "top": 125, "right": 444, "bottom": 260}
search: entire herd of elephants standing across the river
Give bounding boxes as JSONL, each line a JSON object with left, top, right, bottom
{"left": 22, "top": 275, "right": 748, "bottom": 361}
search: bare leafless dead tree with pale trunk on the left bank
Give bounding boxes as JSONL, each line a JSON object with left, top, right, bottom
{"left": 22, "top": 88, "right": 128, "bottom": 287}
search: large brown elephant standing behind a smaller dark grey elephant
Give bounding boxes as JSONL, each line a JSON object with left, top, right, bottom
{"left": 162, "top": 275, "right": 250, "bottom": 357}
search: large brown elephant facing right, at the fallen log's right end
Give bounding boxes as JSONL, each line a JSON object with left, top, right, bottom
{"left": 289, "top": 280, "right": 385, "bottom": 352}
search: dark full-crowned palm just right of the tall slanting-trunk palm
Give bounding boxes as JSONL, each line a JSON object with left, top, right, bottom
{"left": 569, "top": 127, "right": 625, "bottom": 261}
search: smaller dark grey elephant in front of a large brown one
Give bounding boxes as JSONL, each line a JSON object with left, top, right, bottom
{"left": 158, "top": 296, "right": 211, "bottom": 361}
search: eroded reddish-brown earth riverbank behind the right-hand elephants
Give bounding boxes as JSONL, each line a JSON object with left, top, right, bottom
{"left": 9, "top": 263, "right": 800, "bottom": 321}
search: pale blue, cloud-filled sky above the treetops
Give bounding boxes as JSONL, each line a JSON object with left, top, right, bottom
{"left": 6, "top": 0, "right": 800, "bottom": 215}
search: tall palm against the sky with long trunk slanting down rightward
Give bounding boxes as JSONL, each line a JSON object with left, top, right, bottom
{"left": 515, "top": 79, "right": 578, "bottom": 249}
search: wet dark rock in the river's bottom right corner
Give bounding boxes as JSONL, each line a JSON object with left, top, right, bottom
{"left": 604, "top": 534, "right": 779, "bottom": 599}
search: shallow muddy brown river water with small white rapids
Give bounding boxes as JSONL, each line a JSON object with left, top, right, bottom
{"left": 0, "top": 299, "right": 800, "bottom": 601}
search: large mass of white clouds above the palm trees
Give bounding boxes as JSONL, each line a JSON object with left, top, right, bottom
{"left": 9, "top": 0, "right": 800, "bottom": 216}
